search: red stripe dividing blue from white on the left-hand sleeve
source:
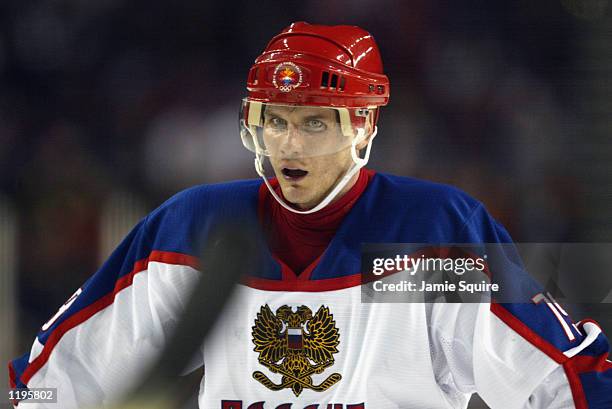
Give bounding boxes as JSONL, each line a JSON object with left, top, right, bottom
{"left": 21, "top": 251, "right": 198, "bottom": 385}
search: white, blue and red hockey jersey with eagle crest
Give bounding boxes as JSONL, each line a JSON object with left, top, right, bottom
{"left": 9, "top": 173, "right": 612, "bottom": 409}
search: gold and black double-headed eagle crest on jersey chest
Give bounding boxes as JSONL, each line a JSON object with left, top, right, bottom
{"left": 252, "top": 304, "right": 342, "bottom": 396}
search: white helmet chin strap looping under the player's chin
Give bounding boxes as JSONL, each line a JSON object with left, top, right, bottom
{"left": 255, "top": 127, "right": 378, "bottom": 214}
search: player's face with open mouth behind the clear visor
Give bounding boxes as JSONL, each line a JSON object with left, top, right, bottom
{"left": 263, "top": 106, "right": 356, "bottom": 210}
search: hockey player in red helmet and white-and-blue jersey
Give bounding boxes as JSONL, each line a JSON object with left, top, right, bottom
{"left": 9, "top": 23, "right": 612, "bottom": 409}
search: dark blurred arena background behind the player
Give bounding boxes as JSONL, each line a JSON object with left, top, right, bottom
{"left": 0, "top": 0, "right": 612, "bottom": 408}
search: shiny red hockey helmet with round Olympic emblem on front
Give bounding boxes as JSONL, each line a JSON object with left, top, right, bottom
{"left": 247, "top": 22, "right": 389, "bottom": 108}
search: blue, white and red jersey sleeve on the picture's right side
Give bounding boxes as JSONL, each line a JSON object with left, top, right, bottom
{"left": 429, "top": 206, "right": 612, "bottom": 409}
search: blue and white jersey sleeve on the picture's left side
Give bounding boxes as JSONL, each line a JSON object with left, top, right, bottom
{"left": 9, "top": 215, "right": 198, "bottom": 409}
